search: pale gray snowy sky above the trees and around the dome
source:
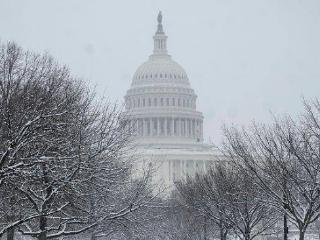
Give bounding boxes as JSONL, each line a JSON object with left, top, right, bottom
{"left": 0, "top": 0, "right": 320, "bottom": 143}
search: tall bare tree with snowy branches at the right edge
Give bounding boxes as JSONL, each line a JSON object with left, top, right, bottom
{"left": 224, "top": 98, "right": 320, "bottom": 240}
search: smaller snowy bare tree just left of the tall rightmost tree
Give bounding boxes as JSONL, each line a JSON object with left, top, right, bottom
{"left": 218, "top": 162, "right": 278, "bottom": 240}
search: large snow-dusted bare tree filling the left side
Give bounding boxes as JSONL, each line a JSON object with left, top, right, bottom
{"left": 0, "top": 43, "right": 154, "bottom": 240}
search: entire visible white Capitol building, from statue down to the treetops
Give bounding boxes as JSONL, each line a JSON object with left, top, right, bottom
{"left": 125, "top": 12, "right": 217, "bottom": 187}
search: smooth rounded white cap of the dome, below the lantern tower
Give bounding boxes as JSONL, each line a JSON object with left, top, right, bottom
{"left": 132, "top": 54, "right": 190, "bottom": 86}
